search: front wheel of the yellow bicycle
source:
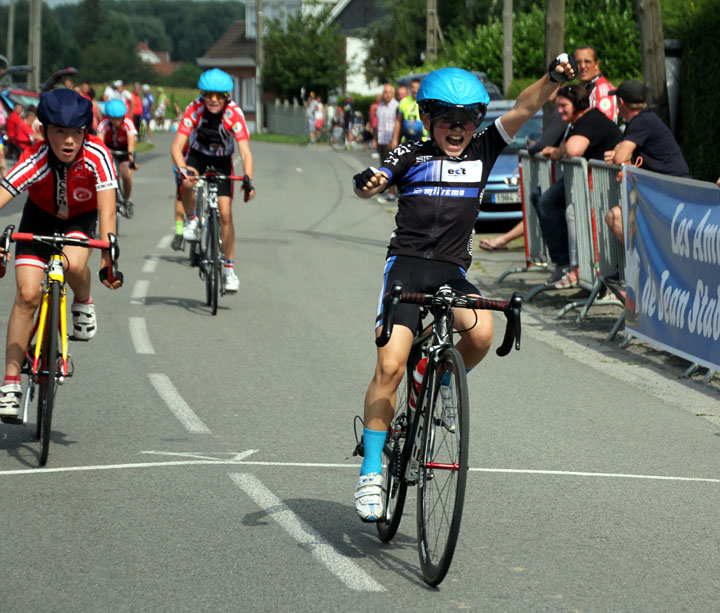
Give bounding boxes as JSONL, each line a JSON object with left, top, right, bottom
{"left": 37, "top": 283, "right": 60, "bottom": 466}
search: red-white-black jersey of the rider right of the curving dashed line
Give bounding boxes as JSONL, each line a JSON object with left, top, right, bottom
{"left": 178, "top": 97, "right": 250, "bottom": 157}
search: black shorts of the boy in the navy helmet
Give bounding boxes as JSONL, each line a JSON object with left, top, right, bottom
{"left": 15, "top": 198, "right": 97, "bottom": 268}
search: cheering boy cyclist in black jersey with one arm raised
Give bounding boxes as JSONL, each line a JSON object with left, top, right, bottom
{"left": 353, "top": 53, "right": 577, "bottom": 521}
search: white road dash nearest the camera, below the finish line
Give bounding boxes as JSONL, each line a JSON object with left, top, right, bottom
{"left": 230, "top": 473, "right": 385, "bottom": 592}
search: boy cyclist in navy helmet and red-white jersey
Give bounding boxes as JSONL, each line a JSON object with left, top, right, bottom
{"left": 0, "top": 89, "right": 122, "bottom": 417}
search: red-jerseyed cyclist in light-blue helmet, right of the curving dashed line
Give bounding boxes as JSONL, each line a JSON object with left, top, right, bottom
{"left": 170, "top": 68, "right": 255, "bottom": 293}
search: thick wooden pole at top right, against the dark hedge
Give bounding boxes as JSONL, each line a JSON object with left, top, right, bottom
{"left": 637, "top": 0, "right": 670, "bottom": 126}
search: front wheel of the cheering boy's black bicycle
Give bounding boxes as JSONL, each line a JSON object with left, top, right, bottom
{"left": 417, "top": 347, "right": 469, "bottom": 585}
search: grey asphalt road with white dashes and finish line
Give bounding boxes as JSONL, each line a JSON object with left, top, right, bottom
{"left": 0, "top": 135, "right": 720, "bottom": 612}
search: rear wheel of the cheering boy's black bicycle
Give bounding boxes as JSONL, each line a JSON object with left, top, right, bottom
{"left": 376, "top": 348, "right": 421, "bottom": 543}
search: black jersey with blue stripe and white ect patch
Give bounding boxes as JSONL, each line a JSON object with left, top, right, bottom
{"left": 380, "top": 119, "right": 513, "bottom": 270}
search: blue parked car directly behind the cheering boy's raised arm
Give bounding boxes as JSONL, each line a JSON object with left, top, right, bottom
{"left": 475, "top": 100, "right": 543, "bottom": 228}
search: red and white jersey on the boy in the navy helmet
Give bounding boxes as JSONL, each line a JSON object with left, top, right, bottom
{"left": 0, "top": 134, "right": 117, "bottom": 219}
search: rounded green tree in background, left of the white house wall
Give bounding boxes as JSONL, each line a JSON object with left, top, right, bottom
{"left": 262, "top": 7, "right": 347, "bottom": 98}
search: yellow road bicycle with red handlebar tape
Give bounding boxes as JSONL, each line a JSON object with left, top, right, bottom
{"left": 0, "top": 225, "right": 120, "bottom": 466}
